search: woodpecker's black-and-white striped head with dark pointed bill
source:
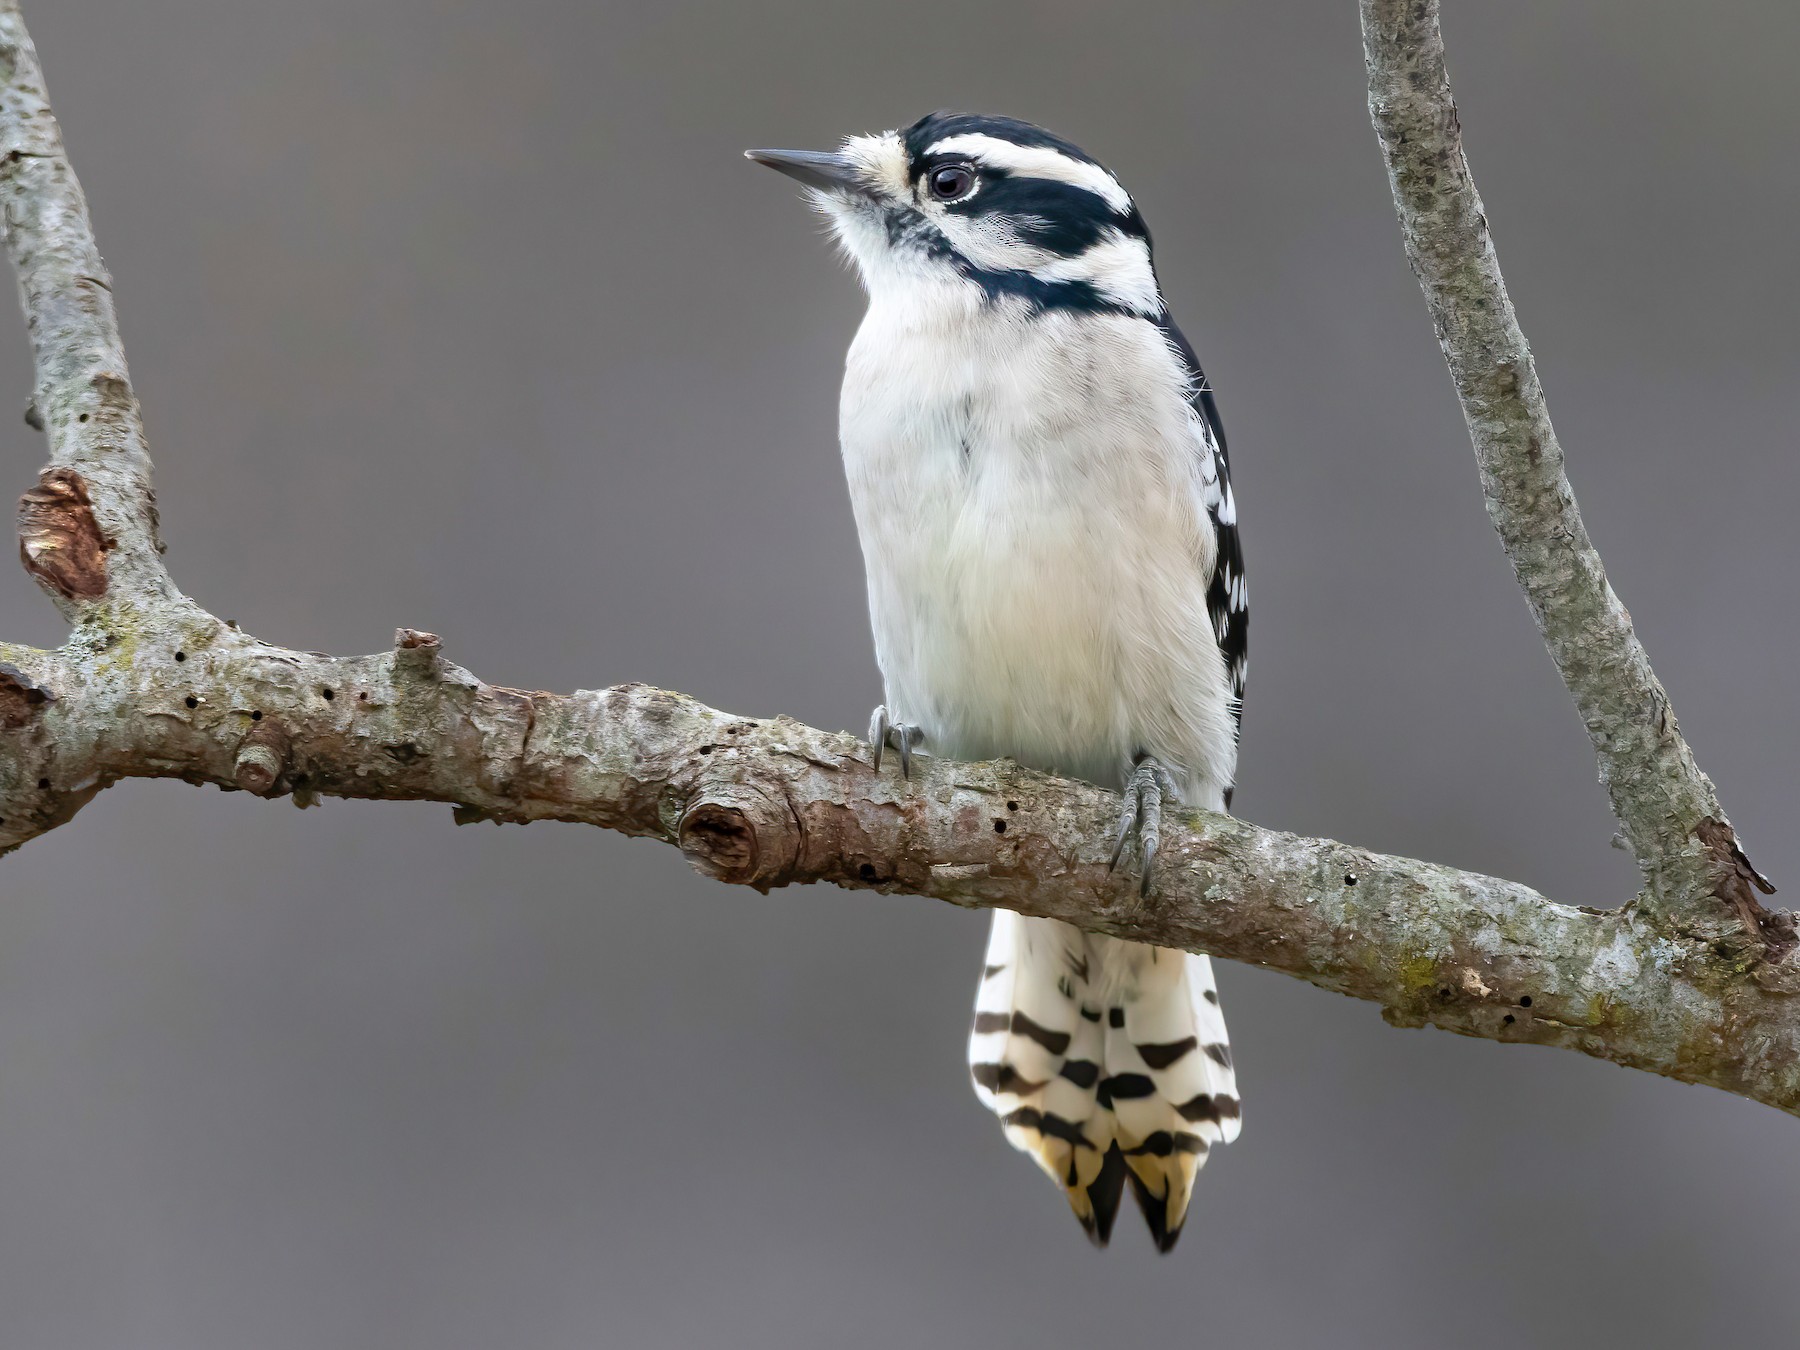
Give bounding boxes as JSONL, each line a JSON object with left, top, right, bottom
{"left": 745, "top": 113, "right": 1163, "bottom": 319}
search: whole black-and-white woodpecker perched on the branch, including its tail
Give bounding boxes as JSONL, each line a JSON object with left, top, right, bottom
{"left": 751, "top": 113, "right": 1249, "bottom": 1251}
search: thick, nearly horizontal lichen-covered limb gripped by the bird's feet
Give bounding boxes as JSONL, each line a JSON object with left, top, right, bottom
{"left": 10, "top": 621, "right": 1800, "bottom": 1112}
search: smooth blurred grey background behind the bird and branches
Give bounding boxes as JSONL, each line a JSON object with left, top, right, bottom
{"left": 0, "top": 0, "right": 1800, "bottom": 1350}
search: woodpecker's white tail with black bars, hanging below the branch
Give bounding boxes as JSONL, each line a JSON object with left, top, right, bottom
{"left": 968, "top": 909, "right": 1238, "bottom": 1251}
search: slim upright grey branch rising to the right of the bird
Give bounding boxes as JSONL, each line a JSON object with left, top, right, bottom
{"left": 1361, "top": 0, "right": 1771, "bottom": 943}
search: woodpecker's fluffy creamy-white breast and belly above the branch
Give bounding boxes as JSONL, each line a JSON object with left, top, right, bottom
{"left": 841, "top": 283, "right": 1237, "bottom": 805}
